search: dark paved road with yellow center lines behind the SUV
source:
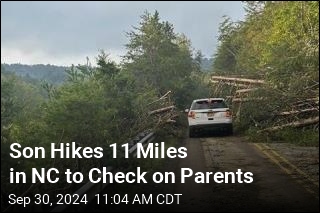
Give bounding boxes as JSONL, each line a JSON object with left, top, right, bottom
{"left": 89, "top": 136, "right": 319, "bottom": 212}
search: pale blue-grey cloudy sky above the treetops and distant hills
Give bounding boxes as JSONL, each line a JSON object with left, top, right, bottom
{"left": 1, "top": 1, "right": 244, "bottom": 65}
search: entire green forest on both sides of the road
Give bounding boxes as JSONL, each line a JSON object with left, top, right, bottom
{"left": 1, "top": 1, "right": 319, "bottom": 208}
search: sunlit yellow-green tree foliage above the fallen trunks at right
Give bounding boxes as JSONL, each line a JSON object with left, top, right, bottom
{"left": 214, "top": 1, "right": 319, "bottom": 89}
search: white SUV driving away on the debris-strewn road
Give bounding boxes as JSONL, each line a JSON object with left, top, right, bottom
{"left": 186, "top": 98, "right": 233, "bottom": 137}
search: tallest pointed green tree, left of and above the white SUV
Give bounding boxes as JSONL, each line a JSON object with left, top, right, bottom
{"left": 123, "top": 11, "right": 210, "bottom": 108}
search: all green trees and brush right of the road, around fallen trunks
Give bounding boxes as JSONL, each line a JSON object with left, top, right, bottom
{"left": 213, "top": 1, "right": 319, "bottom": 143}
